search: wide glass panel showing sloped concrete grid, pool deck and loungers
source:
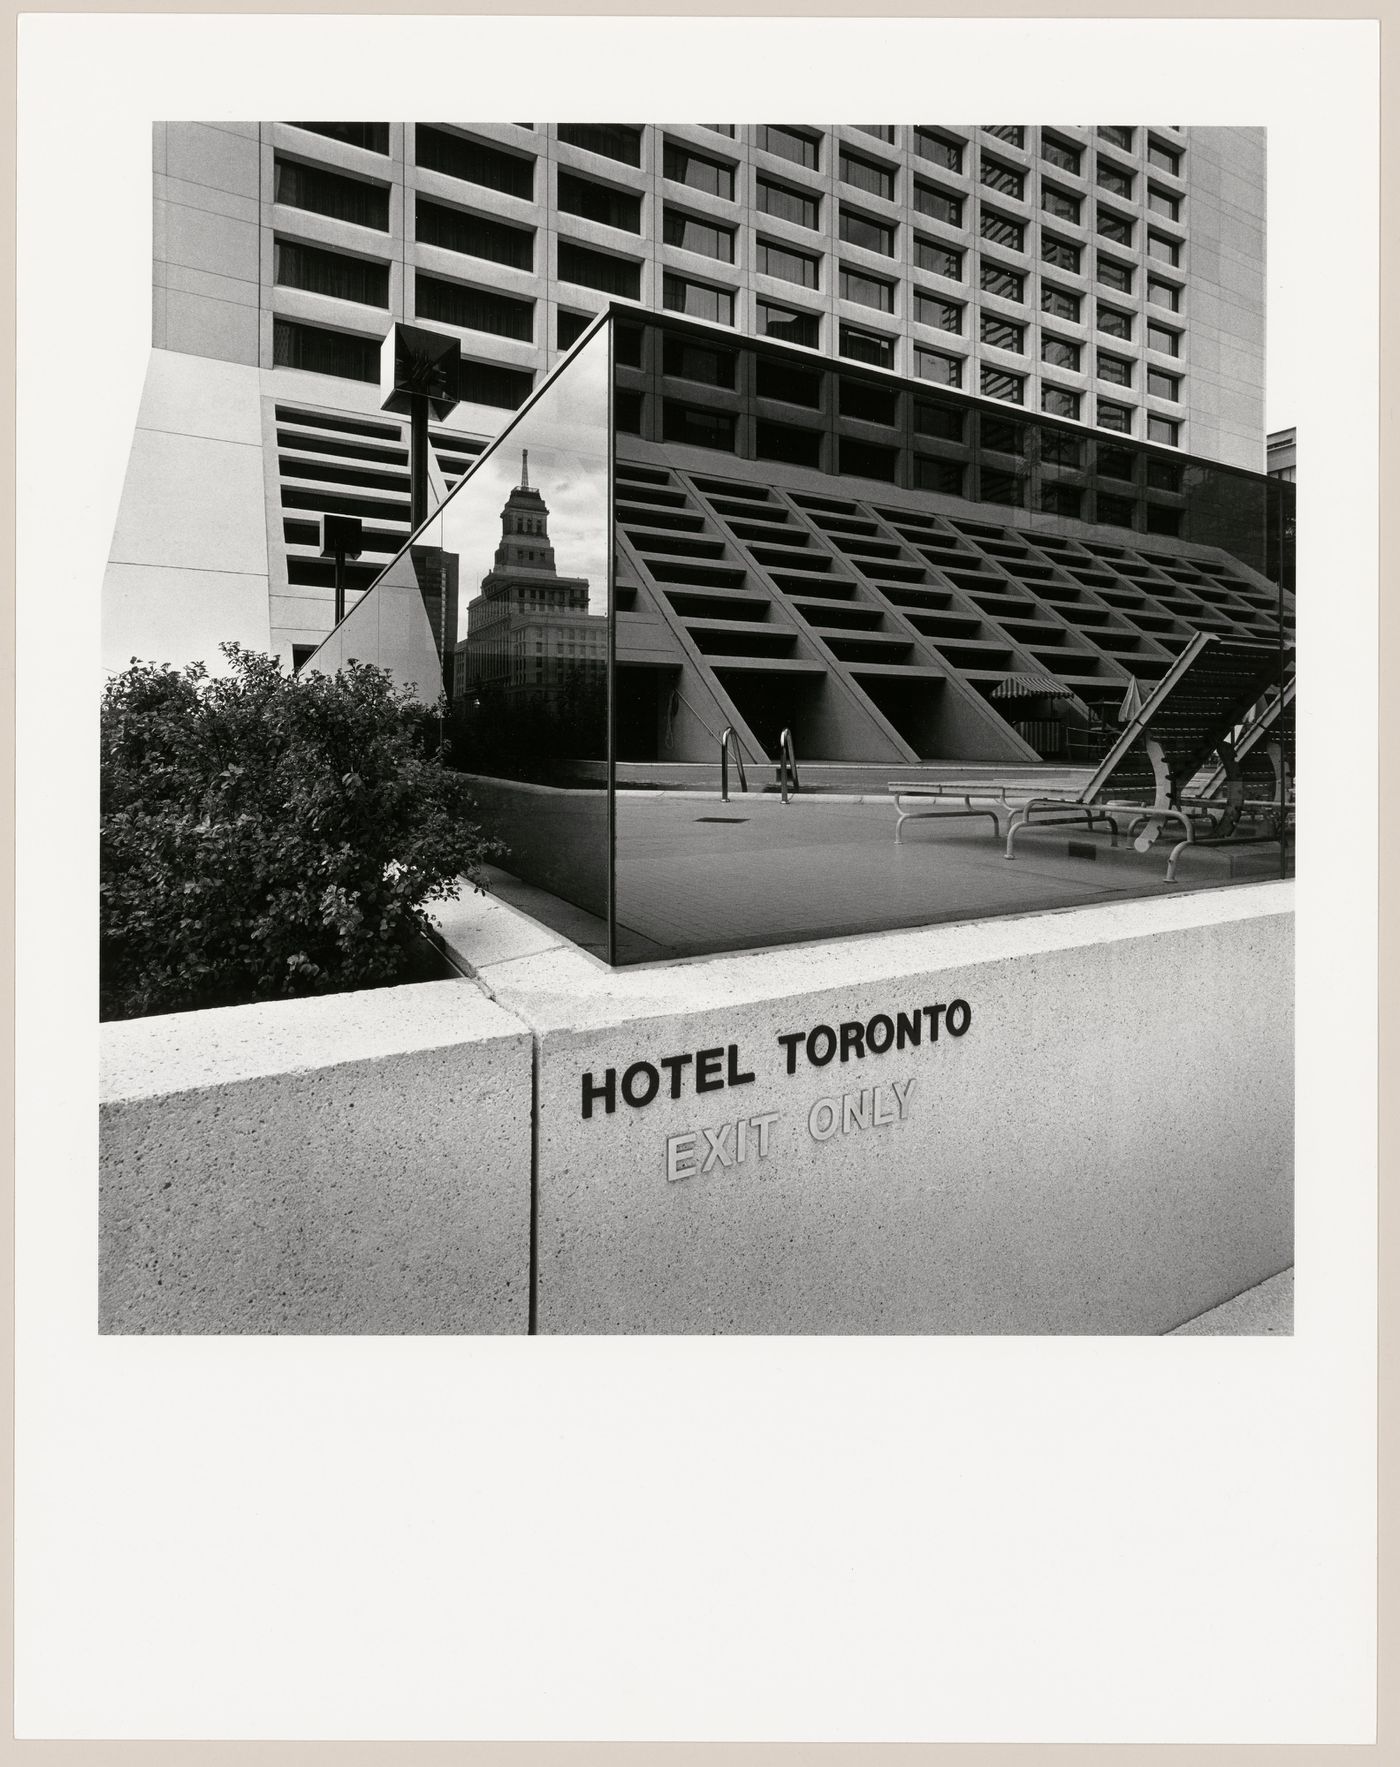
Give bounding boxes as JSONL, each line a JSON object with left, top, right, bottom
{"left": 613, "top": 313, "right": 1292, "bottom": 963}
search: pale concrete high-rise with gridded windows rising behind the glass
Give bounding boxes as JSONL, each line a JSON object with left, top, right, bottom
{"left": 104, "top": 122, "right": 1264, "bottom": 666}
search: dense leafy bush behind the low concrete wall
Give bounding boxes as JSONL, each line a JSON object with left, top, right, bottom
{"left": 101, "top": 645, "right": 502, "bottom": 1018}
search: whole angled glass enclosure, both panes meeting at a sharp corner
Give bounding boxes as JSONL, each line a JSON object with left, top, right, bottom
{"left": 309, "top": 307, "right": 1294, "bottom": 963}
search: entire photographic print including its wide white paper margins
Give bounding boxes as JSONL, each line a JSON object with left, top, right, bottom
{"left": 18, "top": 16, "right": 1382, "bottom": 1742}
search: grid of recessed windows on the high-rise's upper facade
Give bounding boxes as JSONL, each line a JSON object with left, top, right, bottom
{"left": 274, "top": 124, "right": 1216, "bottom": 465}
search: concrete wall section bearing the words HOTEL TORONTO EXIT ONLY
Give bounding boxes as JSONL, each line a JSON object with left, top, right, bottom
{"left": 449, "top": 884, "right": 1292, "bottom": 1334}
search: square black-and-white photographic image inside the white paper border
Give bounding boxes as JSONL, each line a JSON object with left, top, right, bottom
{"left": 101, "top": 120, "right": 1306, "bottom": 1334}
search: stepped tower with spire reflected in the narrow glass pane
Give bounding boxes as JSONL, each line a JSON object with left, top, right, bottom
{"left": 453, "top": 449, "right": 608, "bottom": 700}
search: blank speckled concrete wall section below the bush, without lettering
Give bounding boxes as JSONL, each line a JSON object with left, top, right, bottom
{"left": 99, "top": 981, "right": 532, "bottom": 1334}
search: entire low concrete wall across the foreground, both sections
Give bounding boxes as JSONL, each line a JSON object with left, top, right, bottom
{"left": 101, "top": 884, "right": 1292, "bottom": 1334}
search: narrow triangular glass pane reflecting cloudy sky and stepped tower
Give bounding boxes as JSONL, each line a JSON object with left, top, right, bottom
{"left": 306, "top": 323, "right": 610, "bottom": 952}
